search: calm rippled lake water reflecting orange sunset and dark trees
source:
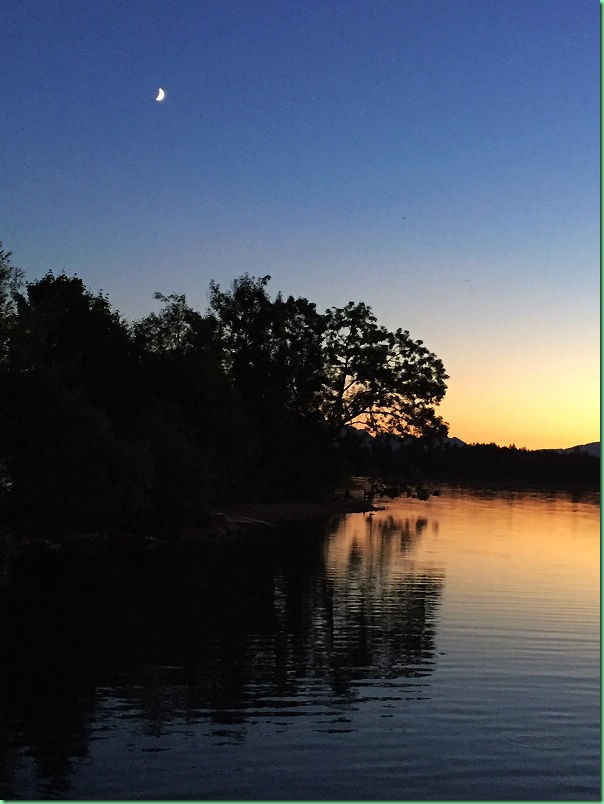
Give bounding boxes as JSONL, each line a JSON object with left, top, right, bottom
{"left": 0, "top": 490, "right": 600, "bottom": 800}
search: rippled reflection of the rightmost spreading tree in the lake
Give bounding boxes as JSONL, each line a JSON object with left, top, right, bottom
{"left": 326, "top": 515, "right": 444, "bottom": 682}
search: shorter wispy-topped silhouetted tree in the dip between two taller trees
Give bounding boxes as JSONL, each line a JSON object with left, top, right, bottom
{"left": 132, "top": 293, "right": 255, "bottom": 508}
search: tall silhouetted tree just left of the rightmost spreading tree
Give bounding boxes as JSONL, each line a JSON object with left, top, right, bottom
{"left": 209, "top": 274, "right": 330, "bottom": 499}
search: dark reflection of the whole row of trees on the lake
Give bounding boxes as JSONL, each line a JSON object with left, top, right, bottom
{"left": 0, "top": 515, "right": 443, "bottom": 798}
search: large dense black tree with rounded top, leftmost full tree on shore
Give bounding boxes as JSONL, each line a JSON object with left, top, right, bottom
{"left": 3, "top": 274, "right": 152, "bottom": 528}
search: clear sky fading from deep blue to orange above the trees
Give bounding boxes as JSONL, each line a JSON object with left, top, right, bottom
{"left": 0, "top": 0, "right": 600, "bottom": 449}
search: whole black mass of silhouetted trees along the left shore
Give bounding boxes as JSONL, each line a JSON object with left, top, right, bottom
{"left": 0, "top": 248, "right": 447, "bottom": 530}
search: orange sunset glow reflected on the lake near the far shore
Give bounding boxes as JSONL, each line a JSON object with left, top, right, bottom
{"left": 326, "top": 490, "right": 600, "bottom": 644}
